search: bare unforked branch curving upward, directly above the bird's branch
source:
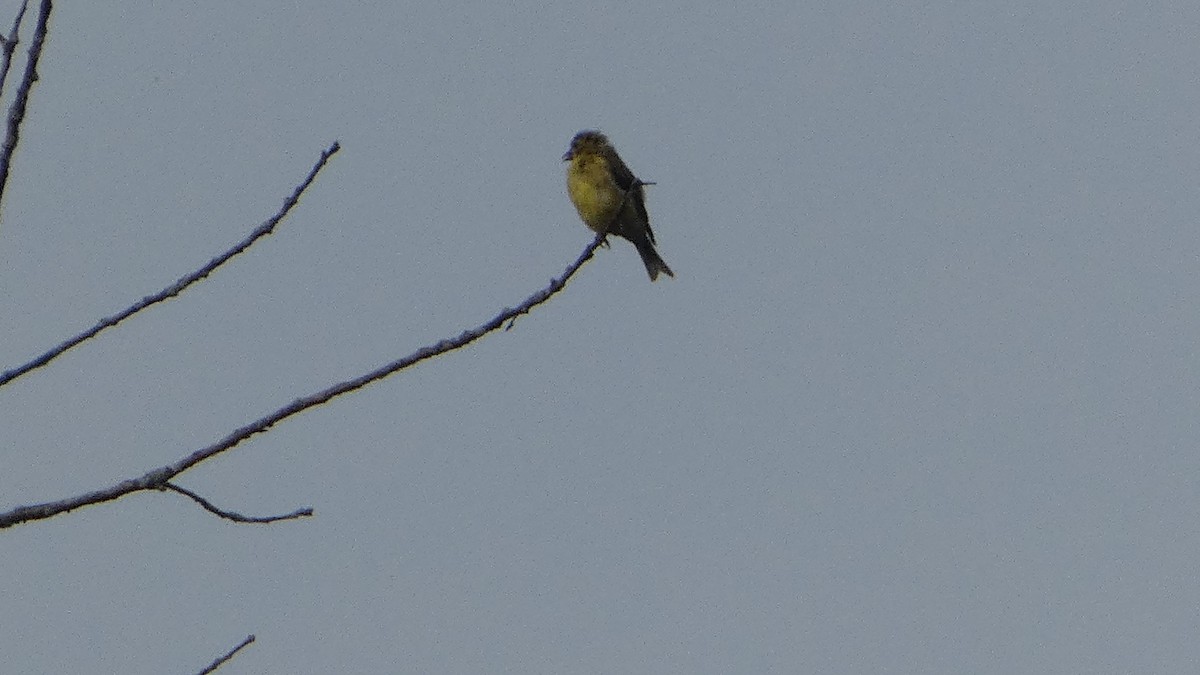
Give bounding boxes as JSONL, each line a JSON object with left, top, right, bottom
{"left": 0, "top": 142, "right": 341, "bottom": 387}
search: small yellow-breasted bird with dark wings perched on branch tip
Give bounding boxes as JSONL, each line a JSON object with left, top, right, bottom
{"left": 563, "top": 130, "right": 674, "bottom": 281}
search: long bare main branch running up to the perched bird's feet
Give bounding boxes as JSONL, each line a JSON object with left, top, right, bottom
{"left": 0, "top": 234, "right": 604, "bottom": 530}
